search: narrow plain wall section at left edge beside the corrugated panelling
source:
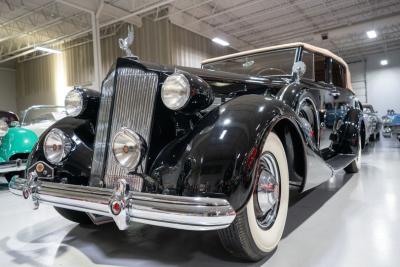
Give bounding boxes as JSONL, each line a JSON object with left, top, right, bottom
{"left": 0, "top": 67, "right": 18, "bottom": 112}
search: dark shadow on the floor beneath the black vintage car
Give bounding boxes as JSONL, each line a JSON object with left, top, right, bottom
{"left": 52, "top": 174, "right": 351, "bottom": 266}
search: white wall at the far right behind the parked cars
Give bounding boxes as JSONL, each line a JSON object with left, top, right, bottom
{"left": 349, "top": 50, "right": 400, "bottom": 116}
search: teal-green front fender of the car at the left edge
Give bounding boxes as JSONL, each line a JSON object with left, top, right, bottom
{"left": 0, "top": 127, "right": 38, "bottom": 161}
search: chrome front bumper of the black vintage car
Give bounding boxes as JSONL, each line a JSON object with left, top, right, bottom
{"left": 9, "top": 177, "right": 236, "bottom": 231}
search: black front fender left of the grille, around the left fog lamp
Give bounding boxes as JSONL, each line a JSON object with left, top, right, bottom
{"left": 27, "top": 117, "right": 95, "bottom": 185}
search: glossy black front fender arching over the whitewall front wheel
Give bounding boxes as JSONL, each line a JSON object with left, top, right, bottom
{"left": 150, "top": 95, "right": 301, "bottom": 213}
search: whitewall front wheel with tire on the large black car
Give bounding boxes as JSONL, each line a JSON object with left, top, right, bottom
{"left": 218, "top": 133, "right": 289, "bottom": 261}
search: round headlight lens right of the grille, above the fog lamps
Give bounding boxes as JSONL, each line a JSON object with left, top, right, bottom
{"left": 161, "top": 73, "right": 190, "bottom": 110}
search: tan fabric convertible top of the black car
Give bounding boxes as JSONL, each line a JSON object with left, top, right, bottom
{"left": 202, "top": 42, "right": 353, "bottom": 90}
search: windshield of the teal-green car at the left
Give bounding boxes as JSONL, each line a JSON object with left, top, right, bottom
{"left": 22, "top": 107, "right": 67, "bottom": 125}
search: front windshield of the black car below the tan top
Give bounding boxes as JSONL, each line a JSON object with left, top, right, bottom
{"left": 203, "top": 48, "right": 296, "bottom": 76}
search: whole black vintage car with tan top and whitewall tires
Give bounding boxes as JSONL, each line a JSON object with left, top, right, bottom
{"left": 10, "top": 43, "right": 362, "bottom": 260}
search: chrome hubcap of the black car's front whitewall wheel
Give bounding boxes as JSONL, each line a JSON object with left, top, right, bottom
{"left": 254, "top": 153, "right": 280, "bottom": 229}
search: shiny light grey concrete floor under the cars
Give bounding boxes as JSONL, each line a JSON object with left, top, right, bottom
{"left": 0, "top": 139, "right": 400, "bottom": 267}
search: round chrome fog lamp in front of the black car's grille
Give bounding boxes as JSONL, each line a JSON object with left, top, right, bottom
{"left": 112, "top": 128, "right": 146, "bottom": 170}
